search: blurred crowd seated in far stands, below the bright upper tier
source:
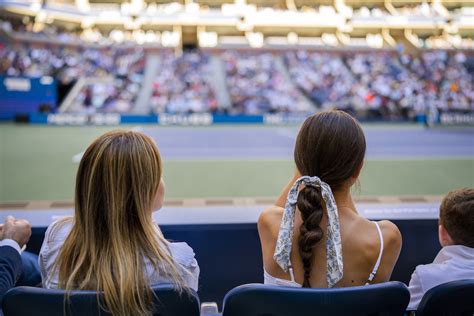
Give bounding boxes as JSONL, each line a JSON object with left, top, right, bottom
{"left": 0, "top": 36, "right": 474, "bottom": 119}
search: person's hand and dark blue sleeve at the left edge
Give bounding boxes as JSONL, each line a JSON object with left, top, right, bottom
{"left": 0, "top": 216, "right": 31, "bottom": 304}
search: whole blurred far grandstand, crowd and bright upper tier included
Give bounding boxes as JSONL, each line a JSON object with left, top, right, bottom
{"left": 0, "top": 0, "right": 474, "bottom": 120}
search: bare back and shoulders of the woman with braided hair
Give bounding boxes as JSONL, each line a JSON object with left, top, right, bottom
{"left": 258, "top": 206, "right": 401, "bottom": 288}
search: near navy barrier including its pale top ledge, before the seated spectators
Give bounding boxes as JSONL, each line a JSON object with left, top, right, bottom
{"left": 9, "top": 202, "right": 441, "bottom": 306}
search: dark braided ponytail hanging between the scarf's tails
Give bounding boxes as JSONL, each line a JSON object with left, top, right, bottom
{"left": 296, "top": 186, "right": 323, "bottom": 288}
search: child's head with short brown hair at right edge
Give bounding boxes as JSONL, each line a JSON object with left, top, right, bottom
{"left": 439, "top": 188, "right": 474, "bottom": 248}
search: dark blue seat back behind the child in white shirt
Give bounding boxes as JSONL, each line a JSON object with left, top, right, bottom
{"left": 416, "top": 280, "right": 474, "bottom": 316}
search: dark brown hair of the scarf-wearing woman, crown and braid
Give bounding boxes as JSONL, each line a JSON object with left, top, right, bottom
{"left": 294, "top": 111, "right": 366, "bottom": 287}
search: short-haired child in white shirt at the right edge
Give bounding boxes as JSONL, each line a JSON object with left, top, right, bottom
{"left": 408, "top": 188, "right": 474, "bottom": 310}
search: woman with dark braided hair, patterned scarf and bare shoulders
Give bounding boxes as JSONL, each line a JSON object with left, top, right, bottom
{"left": 258, "top": 111, "right": 401, "bottom": 288}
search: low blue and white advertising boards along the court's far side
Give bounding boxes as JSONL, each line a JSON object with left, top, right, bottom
{"left": 21, "top": 110, "right": 474, "bottom": 126}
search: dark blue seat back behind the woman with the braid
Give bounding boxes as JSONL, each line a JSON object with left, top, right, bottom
{"left": 223, "top": 282, "right": 410, "bottom": 316}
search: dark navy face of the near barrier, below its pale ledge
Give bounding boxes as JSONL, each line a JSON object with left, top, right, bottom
{"left": 22, "top": 219, "right": 440, "bottom": 306}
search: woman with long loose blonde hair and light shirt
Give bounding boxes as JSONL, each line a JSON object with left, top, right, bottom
{"left": 39, "top": 131, "right": 199, "bottom": 315}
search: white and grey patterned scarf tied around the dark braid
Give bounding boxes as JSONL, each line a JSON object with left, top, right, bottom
{"left": 273, "top": 176, "right": 343, "bottom": 288}
